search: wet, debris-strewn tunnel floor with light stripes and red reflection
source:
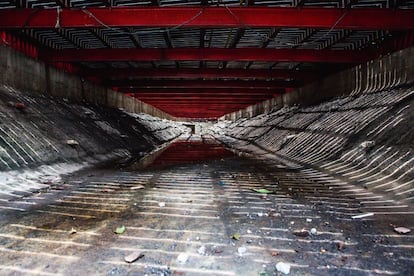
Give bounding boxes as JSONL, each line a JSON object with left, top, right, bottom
{"left": 0, "top": 143, "right": 414, "bottom": 276}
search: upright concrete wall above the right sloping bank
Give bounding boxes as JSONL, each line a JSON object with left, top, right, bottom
{"left": 221, "top": 47, "right": 414, "bottom": 121}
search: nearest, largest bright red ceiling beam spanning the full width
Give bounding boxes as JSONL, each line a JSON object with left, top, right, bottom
{"left": 0, "top": 7, "right": 414, "bottom": 30}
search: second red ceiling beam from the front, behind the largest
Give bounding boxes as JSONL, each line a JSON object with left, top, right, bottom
{"left": 39, "top": 48, "right": 374, "bottom": 63}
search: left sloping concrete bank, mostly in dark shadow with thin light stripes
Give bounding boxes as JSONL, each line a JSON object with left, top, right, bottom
{"left": 0, "top": 83, "right": 186, "bottom": 192}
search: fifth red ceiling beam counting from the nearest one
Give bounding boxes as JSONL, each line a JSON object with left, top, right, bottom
{"left": 117, "top": 87, "right": 285, "bottom": 94}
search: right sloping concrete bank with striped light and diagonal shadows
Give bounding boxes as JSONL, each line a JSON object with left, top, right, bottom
{"left": 215, "top": 87, "right": 414, "bottom": 203}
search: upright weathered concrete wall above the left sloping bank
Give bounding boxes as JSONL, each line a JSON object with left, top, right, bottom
{"left": 0, "top": 46, "right": 174, "bottom": 120}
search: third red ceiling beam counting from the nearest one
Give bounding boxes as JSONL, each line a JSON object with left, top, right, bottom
{"left": 82, "top": 68, "right": 319, "bottom": 79}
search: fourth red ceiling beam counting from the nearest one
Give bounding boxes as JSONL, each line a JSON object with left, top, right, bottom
{"left": 104, "top": 80, "right": 303, "bottom": 89}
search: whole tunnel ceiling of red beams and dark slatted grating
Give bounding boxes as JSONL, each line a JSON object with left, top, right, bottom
{"left": 0, "top": 0, "right": 414, "bottom": 118}
